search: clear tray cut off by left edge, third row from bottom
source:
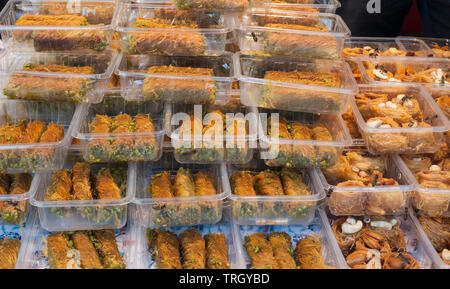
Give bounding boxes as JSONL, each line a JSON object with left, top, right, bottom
{"left": 0, "top": 99, "right": 83, "bottom": 173}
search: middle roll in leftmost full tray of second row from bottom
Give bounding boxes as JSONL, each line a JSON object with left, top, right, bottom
{"left": 72, "top": 162, "right": 93, "bottom": 200}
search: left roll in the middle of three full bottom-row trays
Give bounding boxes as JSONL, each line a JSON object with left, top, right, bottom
{"left": 147, "top": 229, "right": 182, "bottom": 269}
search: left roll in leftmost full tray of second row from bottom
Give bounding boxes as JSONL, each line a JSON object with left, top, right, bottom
{"left": 45, "top": 170, "right": 72, "bottom": 201}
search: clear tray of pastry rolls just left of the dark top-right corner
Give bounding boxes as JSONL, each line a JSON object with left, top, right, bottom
{"left": 239, "top": 9, "right": 350, "bottom": 59}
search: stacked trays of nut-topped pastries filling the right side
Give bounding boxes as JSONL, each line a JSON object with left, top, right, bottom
{"left": 338, "top": 37, "right": 450, "bottom": 268}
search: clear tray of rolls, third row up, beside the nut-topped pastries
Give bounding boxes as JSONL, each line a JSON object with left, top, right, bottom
{"left": 259, "top": 110, "right": 352, "bottom": 168}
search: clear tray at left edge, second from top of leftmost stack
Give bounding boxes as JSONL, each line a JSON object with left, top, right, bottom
{"left": 0, "top": 48, "right": 119, "bottom": 103}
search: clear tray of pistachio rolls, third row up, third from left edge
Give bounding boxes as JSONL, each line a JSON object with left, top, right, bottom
{"left": 168, "top": 95, "right": 258, "bottom": 164}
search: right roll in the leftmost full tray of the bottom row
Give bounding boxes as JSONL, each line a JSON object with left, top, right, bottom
{"left": 92, "top": 230, "right": 125, "bottom": 269}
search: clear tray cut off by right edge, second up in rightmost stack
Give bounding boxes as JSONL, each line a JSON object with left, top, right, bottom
{"left": 394, "top": 156, "right": 450, "bottom": 218}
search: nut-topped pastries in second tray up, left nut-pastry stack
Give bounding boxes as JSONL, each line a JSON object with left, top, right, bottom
{"left": 323, "top": 151, "right": 406, "bottom": 216}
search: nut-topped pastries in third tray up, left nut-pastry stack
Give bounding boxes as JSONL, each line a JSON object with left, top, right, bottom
{"left": 355, "top": 90, "right": 440, "bottom": 154}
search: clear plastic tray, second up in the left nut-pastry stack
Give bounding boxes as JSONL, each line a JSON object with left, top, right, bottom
{"left": 319, "top": 149, "right": 412, "bottom": 216}
